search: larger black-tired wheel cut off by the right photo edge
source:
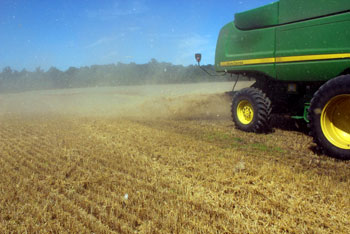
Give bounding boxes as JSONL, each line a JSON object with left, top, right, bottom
{"left": 308, "top": 75, "right": 350, "bottom": 160}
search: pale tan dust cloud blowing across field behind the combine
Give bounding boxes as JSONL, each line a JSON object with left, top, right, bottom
{"left": 0, "top": 82, "right": 251, "bottom": 119}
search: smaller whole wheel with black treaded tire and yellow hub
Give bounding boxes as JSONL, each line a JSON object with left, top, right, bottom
{"left": 231, "top": 87, "right": 272, "bottom": 133}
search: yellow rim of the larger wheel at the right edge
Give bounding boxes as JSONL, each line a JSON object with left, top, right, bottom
{"left": 321, "top": 94, "right": 350, "bottom": 150}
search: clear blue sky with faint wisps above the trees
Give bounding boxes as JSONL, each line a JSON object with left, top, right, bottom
{"left": 0, "top": 0, "right": 273, "bottom": 70}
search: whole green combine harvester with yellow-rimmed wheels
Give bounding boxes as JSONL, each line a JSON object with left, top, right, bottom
{"left": 215, "top": 0, "right": 350, "bottom": 159}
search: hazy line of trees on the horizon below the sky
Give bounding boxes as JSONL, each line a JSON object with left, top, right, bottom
{"left": 0, "top": 59, "right": 237, "bottom": 93}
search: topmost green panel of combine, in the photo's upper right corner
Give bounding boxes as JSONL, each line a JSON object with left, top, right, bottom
{"left": 279, "top": 0, "right": 350, "bottom": 24}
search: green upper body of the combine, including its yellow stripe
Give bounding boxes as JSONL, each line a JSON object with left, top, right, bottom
{"left": 215, "top": 0, "right": 350, "bottom": 82}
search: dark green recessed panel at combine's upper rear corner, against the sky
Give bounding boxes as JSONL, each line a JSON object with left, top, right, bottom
{"left": 235, "top": 2, "right": 279, "bottom": 30}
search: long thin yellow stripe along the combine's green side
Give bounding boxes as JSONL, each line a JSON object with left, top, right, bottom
{"left": 220, "top": 53, "right": 350, "bottom": 67}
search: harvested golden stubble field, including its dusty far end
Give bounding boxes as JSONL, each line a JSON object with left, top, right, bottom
{"left": 0, "top": 83, "right": 350, "bottom": 233}
